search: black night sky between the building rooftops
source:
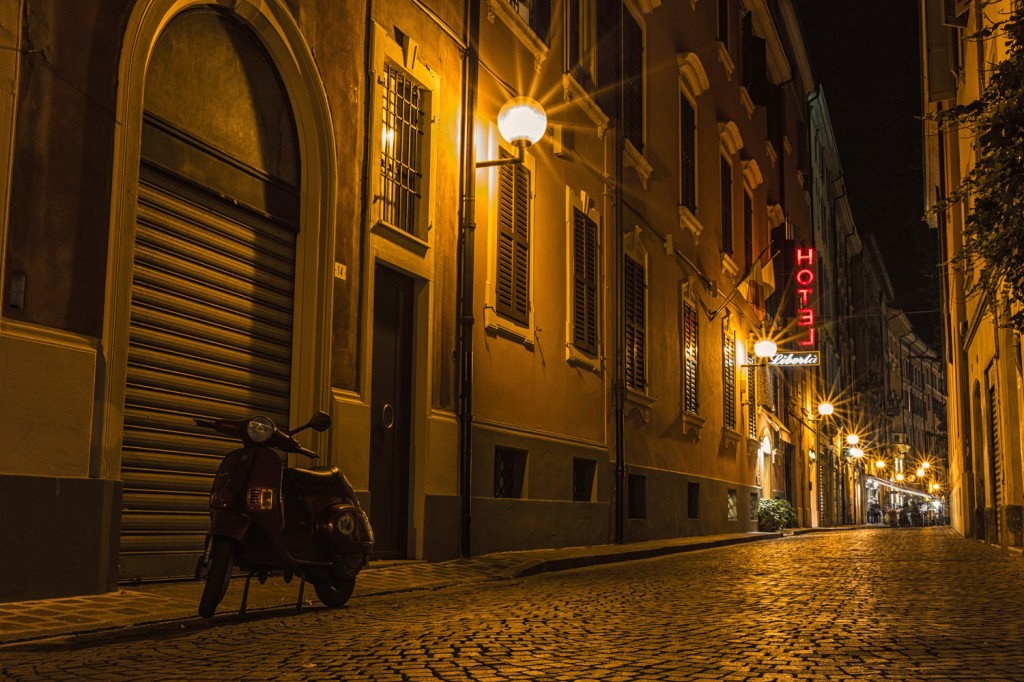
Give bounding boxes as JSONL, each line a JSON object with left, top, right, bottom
{"left": 796, "top": 0, "right": 940, "bottom": 350}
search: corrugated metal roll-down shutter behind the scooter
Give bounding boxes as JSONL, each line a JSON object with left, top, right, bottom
{"left": 120, "top": 163, "right": 296, "bottom": 580}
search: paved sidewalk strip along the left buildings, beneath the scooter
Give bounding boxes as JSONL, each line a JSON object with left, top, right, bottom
{"left": 0, "top": 526, "right": 790, "bottom": 647}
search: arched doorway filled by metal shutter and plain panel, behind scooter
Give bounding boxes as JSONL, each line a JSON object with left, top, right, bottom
{"left": 119, "top": 6, "right": 300, "bottom": 580}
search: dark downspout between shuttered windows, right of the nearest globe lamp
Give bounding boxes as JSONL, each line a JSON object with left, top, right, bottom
{"left": 611, "top": 2, "right": 627, "bottom": 545}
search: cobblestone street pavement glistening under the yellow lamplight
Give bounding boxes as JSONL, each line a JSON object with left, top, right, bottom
{"left": 0, "top": 528, "right": 1024, "bottom": 681}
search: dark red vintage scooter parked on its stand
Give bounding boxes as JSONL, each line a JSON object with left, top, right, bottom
{"left": 195, "top": 412, "right": 374, "bottom": 619}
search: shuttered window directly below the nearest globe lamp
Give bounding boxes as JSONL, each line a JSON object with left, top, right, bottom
{"left": 495, "top": 150, "right": 530, "bottom": 325}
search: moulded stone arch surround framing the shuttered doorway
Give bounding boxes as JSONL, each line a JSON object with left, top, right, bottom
{"left": 98, "top": 0, "right": 338, "bottom": 477}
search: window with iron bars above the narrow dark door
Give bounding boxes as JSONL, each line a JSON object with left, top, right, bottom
{"left": 379, "top": 65, "right": 425, "bottom": 235}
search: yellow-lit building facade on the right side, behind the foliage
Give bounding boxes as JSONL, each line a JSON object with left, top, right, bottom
{"left": 921, "top": 0, "right": 1022, "bottom": 547}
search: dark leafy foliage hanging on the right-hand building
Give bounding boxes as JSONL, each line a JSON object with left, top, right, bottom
{"left": 929, "top": 7, "right": 1024, "bottom": 332}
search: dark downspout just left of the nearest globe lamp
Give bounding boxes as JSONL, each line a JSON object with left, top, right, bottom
{"left": 456, "top": 0, "right": 480, "bottom": 557}
